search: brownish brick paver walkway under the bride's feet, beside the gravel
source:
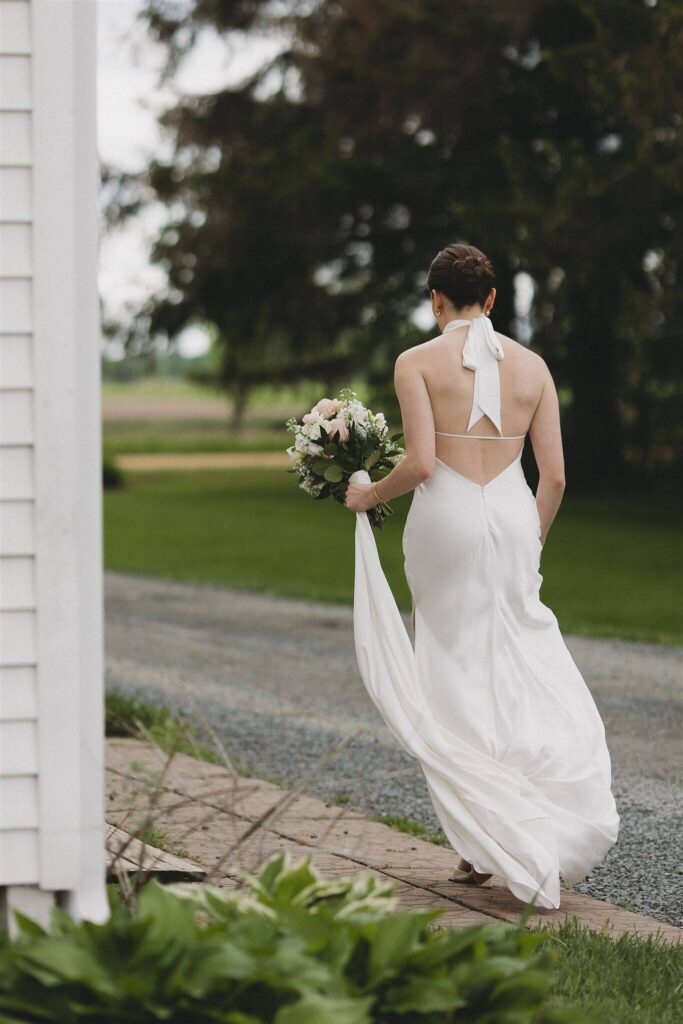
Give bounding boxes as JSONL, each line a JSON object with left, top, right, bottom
{"left": 106, "top": 739, "right": 683, "bottom": 942}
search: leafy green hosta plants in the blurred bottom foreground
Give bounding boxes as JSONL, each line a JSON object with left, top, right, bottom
{"left": 0, "top": 853, "right": 580, "bottom": 1024}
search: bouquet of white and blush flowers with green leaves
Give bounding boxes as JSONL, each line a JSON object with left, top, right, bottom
{"left": 287, "top": 388, "right": 403, "bottom": 529}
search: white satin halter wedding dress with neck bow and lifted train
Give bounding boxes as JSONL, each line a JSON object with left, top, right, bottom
{"left": 352, "top": 315, "right": 620, "bottom": 907}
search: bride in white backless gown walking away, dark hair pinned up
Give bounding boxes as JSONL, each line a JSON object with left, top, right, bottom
{"left": 345, "top": 245, "right": 620, "bottom": 907}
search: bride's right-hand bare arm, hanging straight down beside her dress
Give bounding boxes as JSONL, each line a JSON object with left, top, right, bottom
{"left": 529, "top": 362, "right": 564, "bottom": 544}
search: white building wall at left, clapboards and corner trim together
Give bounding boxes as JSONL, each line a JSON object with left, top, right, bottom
{"left": 0, "top": 0, "right": 105, "bottom": 919}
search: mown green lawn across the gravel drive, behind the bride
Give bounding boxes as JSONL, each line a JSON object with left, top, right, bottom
{"left": 104, "top": 469, "right": 683, "bottom": 644}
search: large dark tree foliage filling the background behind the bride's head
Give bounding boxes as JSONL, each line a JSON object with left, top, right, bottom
{"left": 108, "top": 0, "right": 683, "bottom": 483}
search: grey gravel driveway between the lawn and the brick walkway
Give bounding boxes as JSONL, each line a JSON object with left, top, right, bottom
{"left": 105, "top": 573, "right": 683, "bottom": 926}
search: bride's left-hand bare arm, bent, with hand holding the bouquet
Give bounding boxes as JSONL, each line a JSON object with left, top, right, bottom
{"left": 345, "top": 349, "right": 436, "bottom": 512}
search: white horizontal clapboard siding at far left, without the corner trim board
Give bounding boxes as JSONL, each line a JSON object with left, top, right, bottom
{"left": 0, "top": 0, "right": 40, "bottom": 906}
